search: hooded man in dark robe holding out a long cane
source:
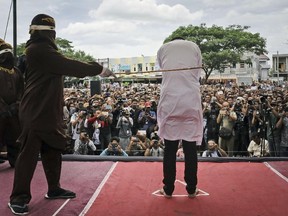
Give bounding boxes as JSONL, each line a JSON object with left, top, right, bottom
{"left": 8, "top": 14, "right": 114, "bottom": 215}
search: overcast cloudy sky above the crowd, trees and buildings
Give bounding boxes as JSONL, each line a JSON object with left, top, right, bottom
{"left": 0, "top": 0, "right": 288, "bottom": 58}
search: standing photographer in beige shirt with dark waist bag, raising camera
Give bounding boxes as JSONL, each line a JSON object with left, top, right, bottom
{"left": 217, "top": 101, "right": 237, "bottom": 157}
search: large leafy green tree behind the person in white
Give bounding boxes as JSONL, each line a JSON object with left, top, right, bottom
{"left": 164, "top": 23, "right": 267, "bottom": 81}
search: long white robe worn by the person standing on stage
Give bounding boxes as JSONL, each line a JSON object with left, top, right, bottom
{"left": 157, "top": 40, "right": 203, "bottom": 145}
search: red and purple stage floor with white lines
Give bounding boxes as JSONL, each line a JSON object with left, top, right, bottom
{"left": 0, "top": 160, "right": 288, "bottom": 216}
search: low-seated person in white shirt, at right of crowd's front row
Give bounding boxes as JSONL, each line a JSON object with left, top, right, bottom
{"left": 247, "top": 133, "right": 269, "bottom": 157}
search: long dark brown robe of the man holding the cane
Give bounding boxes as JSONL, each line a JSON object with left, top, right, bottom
{"left": 18, "top": 41, "right": 103, "bottom": 149}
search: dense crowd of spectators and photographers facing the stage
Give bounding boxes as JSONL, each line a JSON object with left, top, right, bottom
{"left": 64, "top": 80, "right": 288, "bottom": 157}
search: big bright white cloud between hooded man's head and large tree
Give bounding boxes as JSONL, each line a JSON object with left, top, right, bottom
{"left": 58, "top": 0, "right": 203, "bottom": 57}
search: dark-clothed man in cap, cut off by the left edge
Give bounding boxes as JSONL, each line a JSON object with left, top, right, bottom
{"left": 0, "top": 39, "right": 24, "bottom": 167}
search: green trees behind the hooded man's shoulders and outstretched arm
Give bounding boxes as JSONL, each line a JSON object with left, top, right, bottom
{"left": 17, "top": 38, "right": 95, "bottom": 62}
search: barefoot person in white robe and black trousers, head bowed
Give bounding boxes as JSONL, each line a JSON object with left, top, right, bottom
{"left": 157, "top": 38, "right": 203, "bottom": 197}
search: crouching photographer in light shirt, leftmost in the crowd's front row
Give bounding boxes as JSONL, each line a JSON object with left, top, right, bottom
{"left": 74, "top": 131, "right": 96, "bottom": 155}
